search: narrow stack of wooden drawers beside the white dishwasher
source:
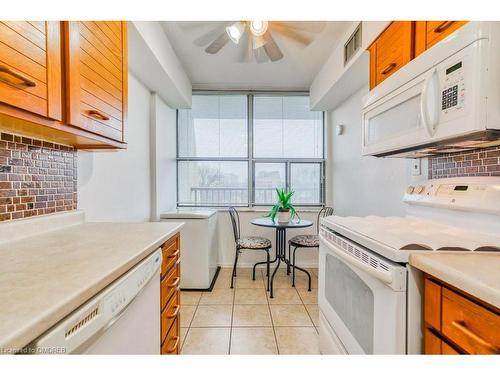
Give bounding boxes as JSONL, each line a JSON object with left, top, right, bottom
{"left": 160, "top": 234, "right": 181, "bottom": 354}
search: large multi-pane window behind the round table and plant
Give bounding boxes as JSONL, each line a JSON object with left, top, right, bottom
{"left": 177, "top": 93, "right": 324, "bottom": 207}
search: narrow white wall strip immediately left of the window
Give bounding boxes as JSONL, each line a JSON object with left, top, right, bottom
{"left": 151, "top": 94, "right": 177, "bottom": 221}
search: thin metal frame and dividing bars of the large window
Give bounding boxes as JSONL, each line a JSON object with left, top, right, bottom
{"left": 175, "top": 90, "right": 326, "bottom": 208}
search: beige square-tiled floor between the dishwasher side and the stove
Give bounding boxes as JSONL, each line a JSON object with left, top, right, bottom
{"left": 181, "top": 268, "right": 319, "bottom": 354}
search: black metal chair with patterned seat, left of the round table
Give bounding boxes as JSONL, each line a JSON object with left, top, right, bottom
{"left": 229, "top": 207, "right": 272, "bottom": 291}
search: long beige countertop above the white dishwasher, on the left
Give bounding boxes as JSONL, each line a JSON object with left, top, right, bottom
{"left": 0, "top": 213, "right": 183, "bottom": 353}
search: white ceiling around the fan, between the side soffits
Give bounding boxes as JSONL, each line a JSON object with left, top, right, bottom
{"left": 162, "top": 21, "right": 351, "bottom": 91}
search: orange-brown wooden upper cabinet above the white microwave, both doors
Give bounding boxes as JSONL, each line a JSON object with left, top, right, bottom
{"left": 368, "top": 21, "right": 466, "bottom": 90}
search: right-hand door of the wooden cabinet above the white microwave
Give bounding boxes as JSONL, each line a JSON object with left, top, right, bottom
{"left": 415, "top": 21, "right": 467, "bottom": 56}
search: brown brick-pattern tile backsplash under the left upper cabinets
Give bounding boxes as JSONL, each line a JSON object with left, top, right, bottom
{"left": 0, "top": 133, "right": 77, "bottom": 221}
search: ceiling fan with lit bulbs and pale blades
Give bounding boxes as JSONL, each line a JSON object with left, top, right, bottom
{"left": 182, "top": 21, "right": 325, "bottom": 63}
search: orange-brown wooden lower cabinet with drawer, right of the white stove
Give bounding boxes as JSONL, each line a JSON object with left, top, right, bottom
{"left": 424, "top": 276, "right": 500, "bottom": 354}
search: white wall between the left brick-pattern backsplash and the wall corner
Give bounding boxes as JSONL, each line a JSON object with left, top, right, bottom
{"left": 78, "top": 74, "right": 151, "bottom": 222}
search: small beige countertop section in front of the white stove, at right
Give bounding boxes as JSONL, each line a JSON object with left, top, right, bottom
{"left": 410, "top": 252, "right": 500, "bottom": 308}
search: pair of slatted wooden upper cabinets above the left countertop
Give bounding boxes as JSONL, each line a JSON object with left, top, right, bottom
{"left": 0, "top": 21, "right": 128, "bottom": 149}
